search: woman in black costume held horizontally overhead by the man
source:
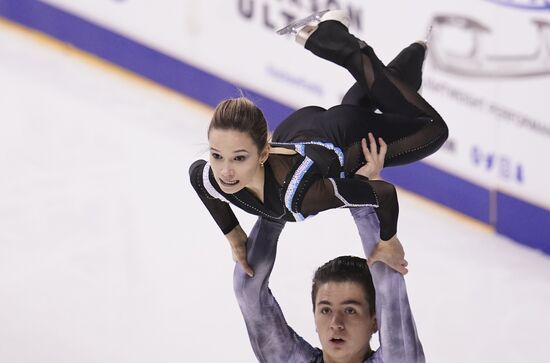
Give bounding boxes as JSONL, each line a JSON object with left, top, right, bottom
{"left": 189, "top": 11, "right": 448, "bottom": 276}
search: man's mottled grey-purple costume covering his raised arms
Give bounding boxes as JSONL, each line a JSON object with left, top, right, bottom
{"left": 233, "top": 207, "right": 425, "bottom": 363}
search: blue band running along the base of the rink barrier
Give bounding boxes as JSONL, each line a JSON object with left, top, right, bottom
{"left": 0, "top": 0, "right": 550, "bottom": 254}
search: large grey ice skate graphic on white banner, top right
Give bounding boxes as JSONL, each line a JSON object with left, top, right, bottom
{"left": 428, "top": 14, "right": 550, "bottom": 78}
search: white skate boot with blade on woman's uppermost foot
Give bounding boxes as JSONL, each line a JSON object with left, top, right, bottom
{"left": 277, "top": 10, "right": 350, "bottom": 46}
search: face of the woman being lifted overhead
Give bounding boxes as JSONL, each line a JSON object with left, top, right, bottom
{"left": 208, "top": 128, "right": 267, "bottom": 194}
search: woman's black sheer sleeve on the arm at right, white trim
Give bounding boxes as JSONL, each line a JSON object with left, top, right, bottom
{"left": 301, "top": 176, "right": 399, "bottom": 240}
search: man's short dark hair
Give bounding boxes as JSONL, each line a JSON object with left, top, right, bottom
{"left": 311, "top": 256, "right": 376, "bottom": 316}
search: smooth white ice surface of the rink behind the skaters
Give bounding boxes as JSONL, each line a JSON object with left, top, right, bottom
{"left": 0, "top": 21, "right": 550, "bottom": 363}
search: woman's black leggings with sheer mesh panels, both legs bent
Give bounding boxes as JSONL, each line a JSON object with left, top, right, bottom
{"left": 273, "top": 21, "right": 448, "bottom": 174}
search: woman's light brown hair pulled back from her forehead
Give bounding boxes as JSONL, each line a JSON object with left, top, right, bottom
{"left": 208, "top": 97, "right": 267, "bottom": 152}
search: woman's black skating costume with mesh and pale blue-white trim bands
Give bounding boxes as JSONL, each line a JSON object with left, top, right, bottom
{"left": 190, "top": 20, "right": 448, "bottom": 240}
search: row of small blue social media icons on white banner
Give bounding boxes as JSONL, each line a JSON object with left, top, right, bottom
{"left": 470, "top": 146, "right": 525, "bottom": 184}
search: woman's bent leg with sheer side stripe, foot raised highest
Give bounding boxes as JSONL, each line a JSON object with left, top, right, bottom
{"left": 288, "top": 9, "right": 448, "bottom": 166}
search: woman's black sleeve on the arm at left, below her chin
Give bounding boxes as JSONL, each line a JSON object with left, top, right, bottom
{"left": 189, "top": 160, "right": 239, "bottom": 234}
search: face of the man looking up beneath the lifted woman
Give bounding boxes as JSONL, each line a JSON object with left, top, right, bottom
{"left": 314, "top": 281, "right": 377, "bottom": 362}
